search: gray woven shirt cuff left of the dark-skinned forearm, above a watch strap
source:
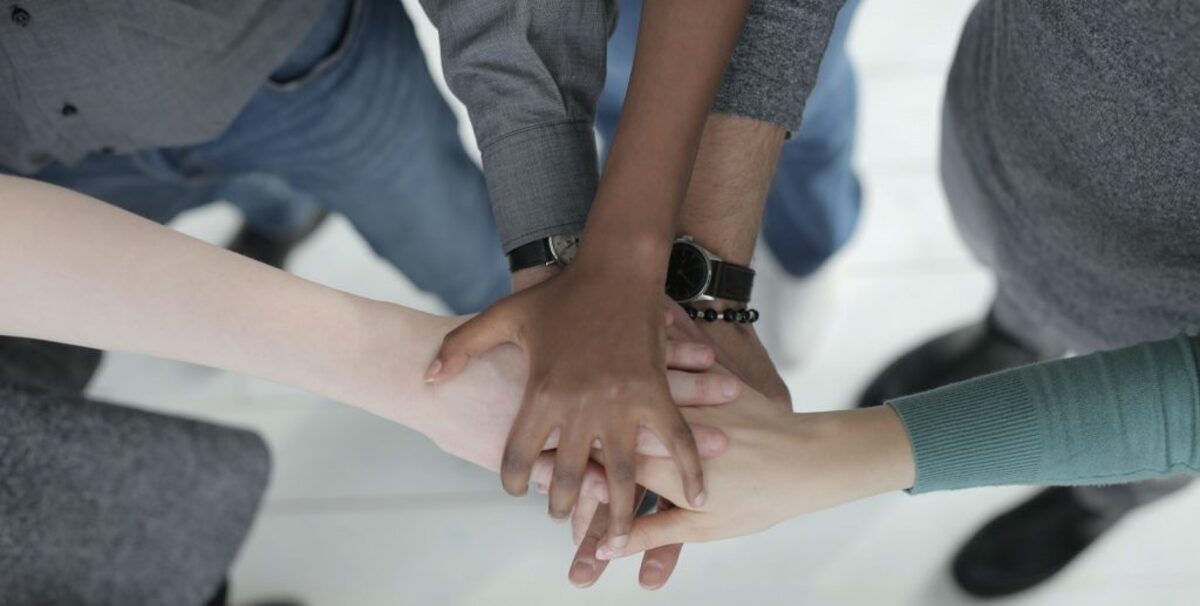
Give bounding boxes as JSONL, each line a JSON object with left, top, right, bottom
{"left": 481, "top": 120, "right": 599, "bottom": 252}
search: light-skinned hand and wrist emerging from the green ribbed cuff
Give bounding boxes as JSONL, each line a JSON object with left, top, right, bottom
{"left": 577, "top": 389, "right": 914, "bottom": 562}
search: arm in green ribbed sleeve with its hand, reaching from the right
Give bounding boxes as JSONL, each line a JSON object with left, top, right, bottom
{"left": 584, "top": 336, "right": 1200, "bottom": 559}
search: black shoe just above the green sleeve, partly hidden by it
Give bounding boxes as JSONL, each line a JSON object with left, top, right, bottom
{"left": 858, "top": 313, "right": 1063, "bottom": 408}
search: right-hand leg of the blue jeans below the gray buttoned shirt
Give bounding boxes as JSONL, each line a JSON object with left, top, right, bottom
{"left": 180, "top": 0, "right": 509, "bottom": 313}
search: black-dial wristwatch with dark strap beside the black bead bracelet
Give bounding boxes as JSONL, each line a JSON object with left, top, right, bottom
{"left": 667, "top": 235, "right": 754, "bottom": 304}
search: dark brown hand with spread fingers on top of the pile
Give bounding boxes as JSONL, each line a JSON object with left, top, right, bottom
{"left": 428, "top": 258, "right": 704, "bottom": 545}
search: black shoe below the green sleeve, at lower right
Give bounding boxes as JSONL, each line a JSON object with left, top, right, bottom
{"left": 953, "top": 487, "right": 1129, "bottom": 598}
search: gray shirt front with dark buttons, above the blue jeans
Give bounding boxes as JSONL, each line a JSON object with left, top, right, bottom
{"left": 0, "top": 0, "right": 325, "bottom": 173}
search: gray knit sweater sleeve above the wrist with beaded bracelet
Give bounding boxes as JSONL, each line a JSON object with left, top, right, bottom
{"left": 713, "top": 0, "right": 845, "bottom": 132}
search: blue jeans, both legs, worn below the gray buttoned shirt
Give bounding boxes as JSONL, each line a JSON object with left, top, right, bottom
{"left": 31, "top": 0, "right": 509, "bottom": 313}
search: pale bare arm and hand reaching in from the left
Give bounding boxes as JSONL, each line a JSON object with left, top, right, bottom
{"left": 0, "top": 176, "right": 736, "bottom": 470}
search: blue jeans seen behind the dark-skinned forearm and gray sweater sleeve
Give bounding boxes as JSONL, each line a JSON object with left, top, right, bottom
{"left": 596, "top": 0, "right": 862, "bottom": 276}
